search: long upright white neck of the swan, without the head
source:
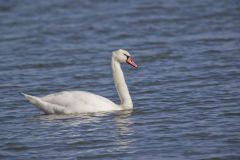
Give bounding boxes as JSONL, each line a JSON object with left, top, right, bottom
{"left": 112, "top": 57, "right": 133, "bottom": 109}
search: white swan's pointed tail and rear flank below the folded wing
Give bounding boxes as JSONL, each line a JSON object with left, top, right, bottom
{"left": 21, "top": 93, "right": 66, "bottom": 114}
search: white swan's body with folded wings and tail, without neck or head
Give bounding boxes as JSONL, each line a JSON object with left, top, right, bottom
{"left": 24, "top": 91, "right": 121, "bottom": 114}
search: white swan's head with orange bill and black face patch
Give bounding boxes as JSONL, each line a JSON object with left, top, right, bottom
{"left": 112, "top": 49, "right": 138, "bottom": 68}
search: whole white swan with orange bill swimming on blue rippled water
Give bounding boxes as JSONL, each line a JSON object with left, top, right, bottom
{"left": 22, "top": 49, "right": 138, "bottom": 114}
